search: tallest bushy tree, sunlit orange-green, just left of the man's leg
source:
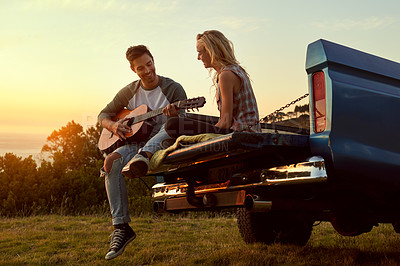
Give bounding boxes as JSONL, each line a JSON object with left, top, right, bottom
{"left": 40, "top": 121, "right": 106, "bottom": 214}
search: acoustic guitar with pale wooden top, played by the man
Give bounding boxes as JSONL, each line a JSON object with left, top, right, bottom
{"left": 97, "top": 97, "right": 206, "bottom": 154}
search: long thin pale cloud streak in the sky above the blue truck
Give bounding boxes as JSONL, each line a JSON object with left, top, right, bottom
{"left": 312, "top": 17, "right": 396, "bottom": 30}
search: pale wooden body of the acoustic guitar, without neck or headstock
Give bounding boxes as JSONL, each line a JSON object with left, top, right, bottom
{"left": 98, "top": 104, "right": 154, "bottom": 154}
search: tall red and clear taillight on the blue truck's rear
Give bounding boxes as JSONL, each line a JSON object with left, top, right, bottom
{"left": 312, "top": 71, "right": 326, "bottom": 133}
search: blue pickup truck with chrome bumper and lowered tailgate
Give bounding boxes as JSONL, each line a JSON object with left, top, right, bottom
{"left": 150, "top": 39, "right": 400, "bottom": 245}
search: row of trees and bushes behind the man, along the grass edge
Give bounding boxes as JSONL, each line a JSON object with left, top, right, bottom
{"left": 0, "top": 121, "right": 155, "bottom": 217}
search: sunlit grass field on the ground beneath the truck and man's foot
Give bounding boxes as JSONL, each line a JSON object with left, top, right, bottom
{"left": 0, "top": 215, "right": 400, "bottom": 265}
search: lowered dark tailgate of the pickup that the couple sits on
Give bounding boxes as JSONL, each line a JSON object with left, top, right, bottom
{"left": 149, "top": 132, "right": 310, "bottom": 182}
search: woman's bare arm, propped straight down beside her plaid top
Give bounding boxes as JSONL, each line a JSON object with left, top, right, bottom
{"left": 215, "top": 71, "right": 240, "bottom": 128}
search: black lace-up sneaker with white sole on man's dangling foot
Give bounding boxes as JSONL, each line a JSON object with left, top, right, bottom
{"left": 106, "top": 226, "right": 136, "bottom": 260}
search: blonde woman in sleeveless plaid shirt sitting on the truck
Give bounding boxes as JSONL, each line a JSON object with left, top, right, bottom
{"left": 165, "top": 30, "right": 261, "bottom": 138}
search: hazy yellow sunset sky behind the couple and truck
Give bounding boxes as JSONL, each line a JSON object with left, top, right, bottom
{"left": 0, "top": 0, "right": 400, "bottom": 155}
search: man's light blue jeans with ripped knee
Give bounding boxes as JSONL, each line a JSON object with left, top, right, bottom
{"left": 100, "top": 123, "right": 170, "bottom": 225}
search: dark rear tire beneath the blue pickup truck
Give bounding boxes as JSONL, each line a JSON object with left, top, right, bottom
{"left": 237, "top": 208, "right": 314, "bottom": 246}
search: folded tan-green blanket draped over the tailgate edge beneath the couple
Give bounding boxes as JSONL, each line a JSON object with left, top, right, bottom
{"left": 150, "top": 133, "right": 221, "bottom": 171}
